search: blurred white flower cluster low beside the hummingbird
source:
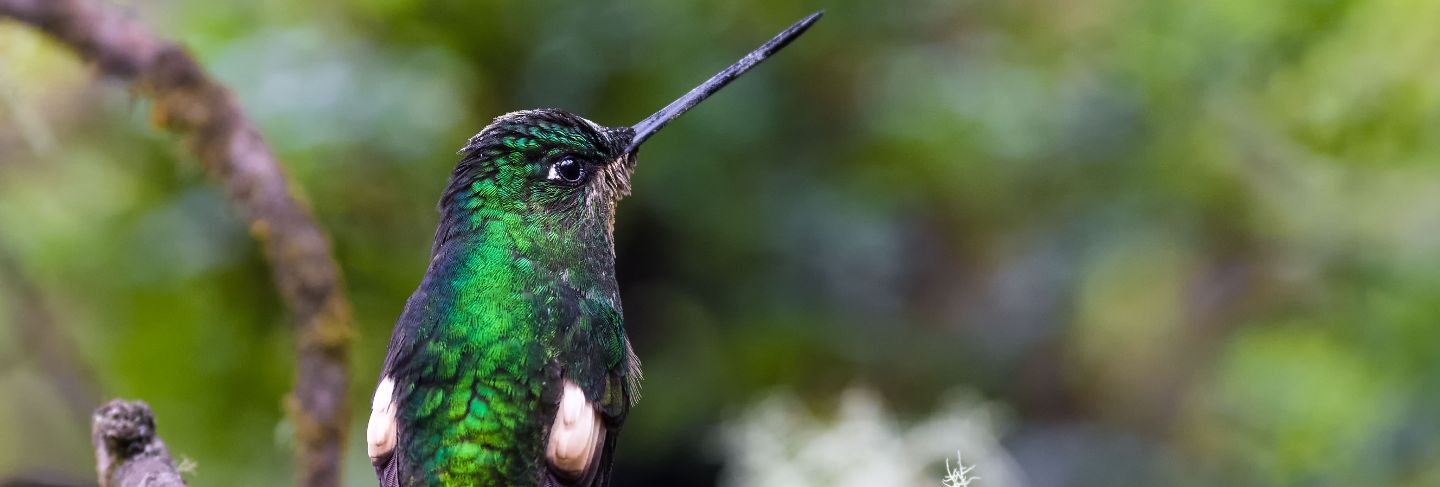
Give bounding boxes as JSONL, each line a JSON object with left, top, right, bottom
{"left": 721, "top": 388, "right": 1025, "bottom": 487}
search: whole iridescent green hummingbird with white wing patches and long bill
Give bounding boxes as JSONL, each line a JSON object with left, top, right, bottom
{"left": 366, "top": 12, "right": 822, "bottom": 487}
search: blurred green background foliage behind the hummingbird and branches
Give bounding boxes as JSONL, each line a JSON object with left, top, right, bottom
{"left": 0, "top": 0, "right": 1440, "bottom": 487}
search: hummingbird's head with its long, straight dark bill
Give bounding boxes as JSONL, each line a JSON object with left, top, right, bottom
{"left": 436, "top": 12, "right": 821, "bottom": 255}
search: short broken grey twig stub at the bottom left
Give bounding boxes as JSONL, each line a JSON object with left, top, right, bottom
{"left": 91, "top": 399, "right": 184, "bottom": 487}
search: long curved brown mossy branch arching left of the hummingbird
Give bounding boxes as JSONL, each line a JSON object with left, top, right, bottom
{"left": 0, "top": 0, "right": 353, "bottom": 487}
